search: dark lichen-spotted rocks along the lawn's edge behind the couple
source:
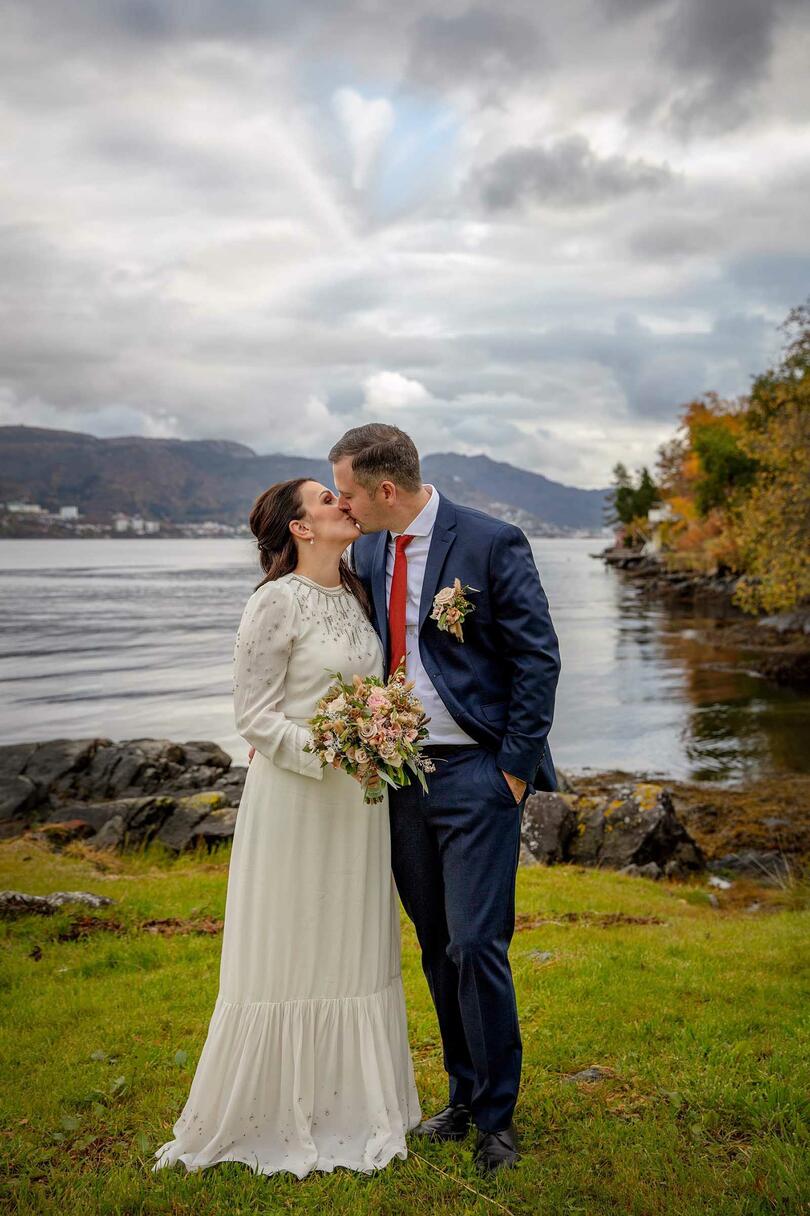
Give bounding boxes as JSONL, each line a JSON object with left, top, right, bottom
{"left": 0, "top": 738, "right": 810, "bottom": 883}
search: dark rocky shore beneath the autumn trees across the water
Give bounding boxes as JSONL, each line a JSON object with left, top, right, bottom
{"left": 591, "top": 546, "right": 810, "bottom": 688}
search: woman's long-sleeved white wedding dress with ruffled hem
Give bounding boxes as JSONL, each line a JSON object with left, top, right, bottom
{"left": 152, "top": 574, "right": 421, "bottom": 1178}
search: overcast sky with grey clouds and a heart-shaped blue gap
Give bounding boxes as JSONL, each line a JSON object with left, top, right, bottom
{"left": 0, "top": 0, "right": 810, "bottom": 488}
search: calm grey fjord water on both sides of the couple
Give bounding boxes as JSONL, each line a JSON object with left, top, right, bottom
{"left": 0, "top": 537, "right": 810, "bottom": 782}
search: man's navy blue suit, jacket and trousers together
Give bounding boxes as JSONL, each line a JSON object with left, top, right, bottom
{"left": 353, "top": 491, "right": 559, "bottom": 1131}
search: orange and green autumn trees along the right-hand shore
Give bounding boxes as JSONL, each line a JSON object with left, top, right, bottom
{"left": 658, "top": 302, "right": 810, "bottom": 612}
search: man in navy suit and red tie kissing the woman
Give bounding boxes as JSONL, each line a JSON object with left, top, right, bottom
{"left": 328, "top": 422, "right": 559, "bottom": 1172}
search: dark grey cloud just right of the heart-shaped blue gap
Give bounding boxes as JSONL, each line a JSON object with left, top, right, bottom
{"left": 472, "top": 135, "right": 674, "bottom": 212}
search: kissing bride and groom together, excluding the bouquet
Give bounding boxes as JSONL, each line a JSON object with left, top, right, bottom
{"left": 152, "top": 423, "right": 559, "bottom": 1178}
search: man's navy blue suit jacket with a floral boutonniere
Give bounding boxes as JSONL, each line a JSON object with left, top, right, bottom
{"left": 351, "top": 490, "right": 559, "bottom": 792}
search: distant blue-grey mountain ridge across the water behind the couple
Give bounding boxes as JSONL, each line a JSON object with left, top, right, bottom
{"left": 0, "top": 427, "right": 607, "bottom": 534}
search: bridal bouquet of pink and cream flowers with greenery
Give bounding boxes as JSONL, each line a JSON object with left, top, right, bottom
{"left": 304, "top": 664, "right": 435, "bottom": 803}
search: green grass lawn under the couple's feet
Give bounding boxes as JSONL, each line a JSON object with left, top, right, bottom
{"left": 0, "top": 840, "right": 810, "bottom": 1216}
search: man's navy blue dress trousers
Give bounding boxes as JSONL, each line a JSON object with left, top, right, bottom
{"left": 389, "top": 744, "right": 528, "bottom": 1131}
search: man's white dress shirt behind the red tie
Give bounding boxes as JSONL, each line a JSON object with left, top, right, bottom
{"left": 386, "top": 485, "right": 476, "bottom": 743}
